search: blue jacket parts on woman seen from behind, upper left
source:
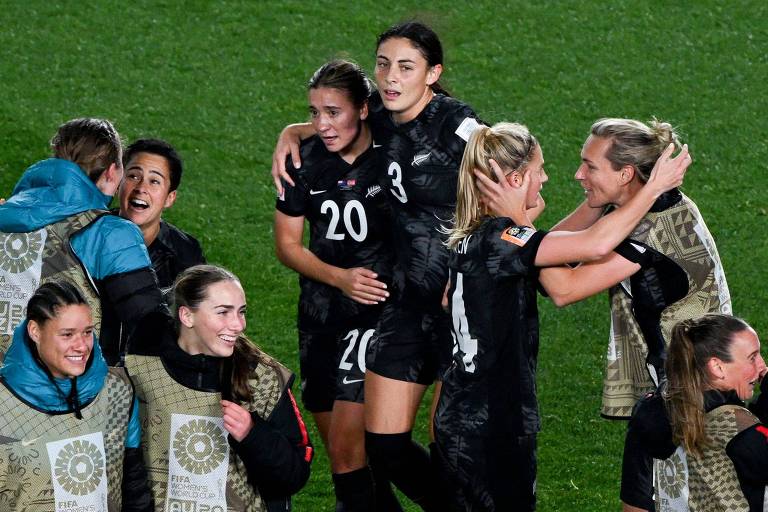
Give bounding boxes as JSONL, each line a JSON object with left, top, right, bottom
{"left": 0, "top": 158, "right": 151, "bottom": 280}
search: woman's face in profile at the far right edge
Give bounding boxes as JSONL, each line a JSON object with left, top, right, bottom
{"left": 713, "top": 328, "right": 766, "bottom": 400}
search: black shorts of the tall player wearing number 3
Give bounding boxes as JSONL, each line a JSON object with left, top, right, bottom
{"left": 367, "top": 300, "right": 453, "bottom": 385}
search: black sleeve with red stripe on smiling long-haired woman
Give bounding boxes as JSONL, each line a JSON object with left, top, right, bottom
{"left": 229, "top": 389, "right": 313, "bottom": 499}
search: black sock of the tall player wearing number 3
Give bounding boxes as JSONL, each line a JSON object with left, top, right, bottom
{"left": 365, "top": 431, "right": 446, "bottom": 512}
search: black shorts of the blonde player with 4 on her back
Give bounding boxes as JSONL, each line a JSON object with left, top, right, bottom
{"left": 435, "top": 432, "right": 536, "bottom": 512}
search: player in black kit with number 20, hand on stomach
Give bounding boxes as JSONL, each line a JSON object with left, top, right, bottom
{"left": 275, "top": 60, "right": 399, "bottom": 512}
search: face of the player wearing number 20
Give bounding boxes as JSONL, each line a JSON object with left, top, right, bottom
{"left": 309, "top": 87, "right": 368, "bottom": 155}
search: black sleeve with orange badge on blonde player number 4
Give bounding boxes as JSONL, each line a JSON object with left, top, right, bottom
{"left": 485, "top": 218, "right": 547, "bottom": 278}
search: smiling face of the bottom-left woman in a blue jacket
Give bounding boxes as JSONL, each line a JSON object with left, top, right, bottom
{"left": 27, "top": 304, "right": 93, "bottom": 379}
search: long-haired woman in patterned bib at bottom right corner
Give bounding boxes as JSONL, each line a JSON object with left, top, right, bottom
{"left": 627, "top": 314, "right": 768, "bottom": 512}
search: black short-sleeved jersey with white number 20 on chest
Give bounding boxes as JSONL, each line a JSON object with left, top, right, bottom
{"left": 275, "top": 136, "right": 393, "bottom": 332}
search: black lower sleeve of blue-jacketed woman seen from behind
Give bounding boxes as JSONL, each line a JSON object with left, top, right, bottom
{"left": 97, "top": 267, "right": 170, "bottom": 365}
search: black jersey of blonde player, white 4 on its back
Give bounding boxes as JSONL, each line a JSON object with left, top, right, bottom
{"left": 435, "top": 218, "right": 546, "bottom": 435}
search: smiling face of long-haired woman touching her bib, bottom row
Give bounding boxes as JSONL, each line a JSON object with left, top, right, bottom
{"left": 179, "top": 280, "right": 245, "bottom": 357}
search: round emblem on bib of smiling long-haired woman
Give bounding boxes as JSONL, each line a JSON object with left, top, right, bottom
{"left": 173, "top": 419, "right": 227, "bottom": 475}
